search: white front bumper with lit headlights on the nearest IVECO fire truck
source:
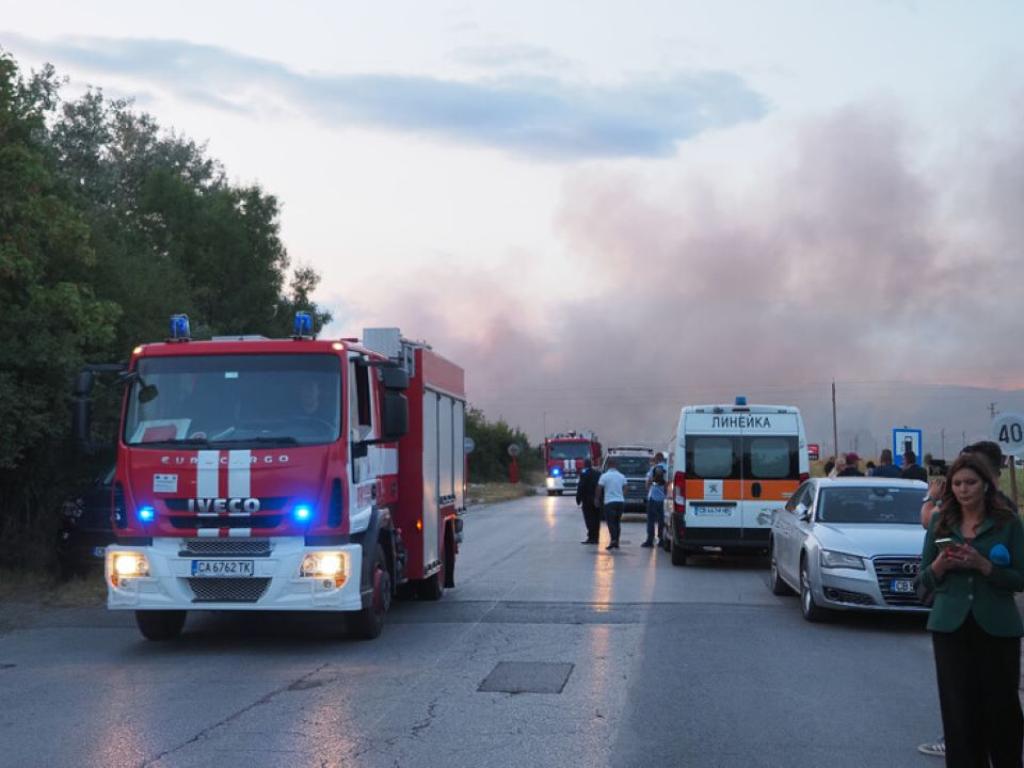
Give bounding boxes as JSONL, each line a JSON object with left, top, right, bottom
{"left": 103, "top": 537, "right": 362, "bottom": 611}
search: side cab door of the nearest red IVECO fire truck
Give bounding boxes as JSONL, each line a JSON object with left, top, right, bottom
{"left": 347, "top": 358, "right": 378, "bottom": 534}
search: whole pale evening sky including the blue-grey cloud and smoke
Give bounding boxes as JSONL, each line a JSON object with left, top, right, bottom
{"left": 0, "top": 0, "right": 1024, "bottom": 450}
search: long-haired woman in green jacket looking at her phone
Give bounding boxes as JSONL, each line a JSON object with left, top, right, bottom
{"left": 921, "top": 454, "right": 1024, "bottom": 768}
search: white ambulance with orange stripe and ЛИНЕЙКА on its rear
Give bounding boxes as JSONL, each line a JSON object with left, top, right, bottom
{"left": 666, "top": 397, "right": 810, "bottom": 565}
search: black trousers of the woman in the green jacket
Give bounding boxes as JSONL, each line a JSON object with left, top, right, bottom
{"left": 932, "top": 615, "right": 1024, "bottom": 768}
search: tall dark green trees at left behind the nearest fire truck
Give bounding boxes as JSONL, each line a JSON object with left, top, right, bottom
{"left": 0, "top": 50, "right": 331, "bottom": 564}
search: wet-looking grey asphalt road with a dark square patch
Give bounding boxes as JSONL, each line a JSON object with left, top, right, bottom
{"left": 0, "top": 497, "right": 941, "bottom": 768}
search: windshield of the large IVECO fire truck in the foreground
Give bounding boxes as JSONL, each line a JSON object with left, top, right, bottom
{"left": 124, "top": 354, "right": 341, "bottom": 447}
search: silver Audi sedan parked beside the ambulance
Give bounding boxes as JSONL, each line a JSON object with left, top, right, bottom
{"left": 769, "top": 477, "right": 928, "bottom": 622}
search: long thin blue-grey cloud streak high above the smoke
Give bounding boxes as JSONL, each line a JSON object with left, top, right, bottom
{"left": 4, "top": 34, "right": 767, "bottom": 160}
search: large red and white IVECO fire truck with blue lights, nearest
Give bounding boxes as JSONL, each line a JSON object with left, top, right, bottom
{"left": 74, "top": 313, "right": 465, "bottom": 640}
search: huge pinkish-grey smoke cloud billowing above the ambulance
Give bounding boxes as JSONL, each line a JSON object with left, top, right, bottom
{"left": 335, "top": 104, "right": 1024, "bottom": 455}
